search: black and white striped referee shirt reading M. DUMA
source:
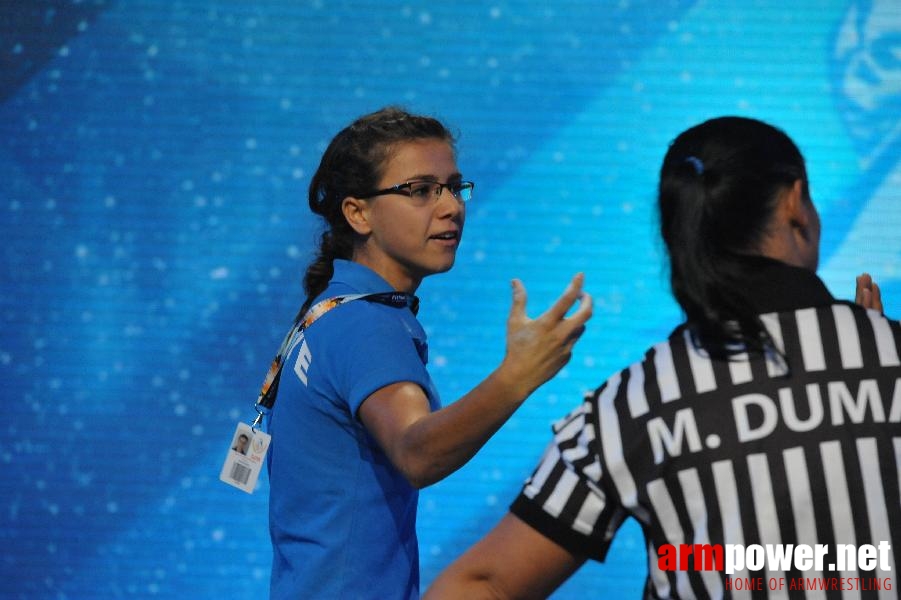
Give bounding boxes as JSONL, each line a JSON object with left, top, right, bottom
{"left": 511, "top": 266, "right": 901, "bottom": 598}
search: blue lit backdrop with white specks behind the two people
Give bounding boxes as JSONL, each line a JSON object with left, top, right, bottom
{"left": 0, "top": 0, "right": 901, "bottom": 599}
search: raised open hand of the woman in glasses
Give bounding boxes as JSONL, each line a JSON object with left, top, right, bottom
{"left": 500, "top": 273, "right": 592, "bottom": 396}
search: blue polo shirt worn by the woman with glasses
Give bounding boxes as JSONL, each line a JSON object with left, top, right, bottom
{"left": 269, "top": 260, "right": 440, "bottom": 600}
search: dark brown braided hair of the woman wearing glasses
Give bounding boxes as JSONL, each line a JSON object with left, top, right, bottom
{"left": 300, "top": 106, "right": 455, "bottom": 314}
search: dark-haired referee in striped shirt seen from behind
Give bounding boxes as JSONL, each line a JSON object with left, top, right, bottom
{"left": 426, "top": 117, "right": 901, "bottom": 599}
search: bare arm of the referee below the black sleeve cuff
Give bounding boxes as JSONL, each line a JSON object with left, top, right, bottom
{"left": 424, "top": 513, "right": 585, "bottom": 600}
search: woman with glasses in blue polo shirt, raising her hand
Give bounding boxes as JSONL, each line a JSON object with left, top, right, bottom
{"left": 269, "top": 108, "right": 591, "bottom": 599}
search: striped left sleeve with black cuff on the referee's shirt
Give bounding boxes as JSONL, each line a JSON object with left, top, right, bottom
{"left": 510, "top": 398, "right": 625, "bottom": 561}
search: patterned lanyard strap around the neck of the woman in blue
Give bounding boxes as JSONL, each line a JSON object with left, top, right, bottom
{"left": 251, "top": 292, "right": 419, "bottom": 431}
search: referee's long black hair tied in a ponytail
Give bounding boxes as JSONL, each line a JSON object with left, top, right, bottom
{"left": 658, "top": 117, "right": 811, "bottom": 358}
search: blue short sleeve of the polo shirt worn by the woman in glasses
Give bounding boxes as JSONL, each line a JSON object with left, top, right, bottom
{"left": 311, "top": 301, "right": 431, "bottom": 416}
